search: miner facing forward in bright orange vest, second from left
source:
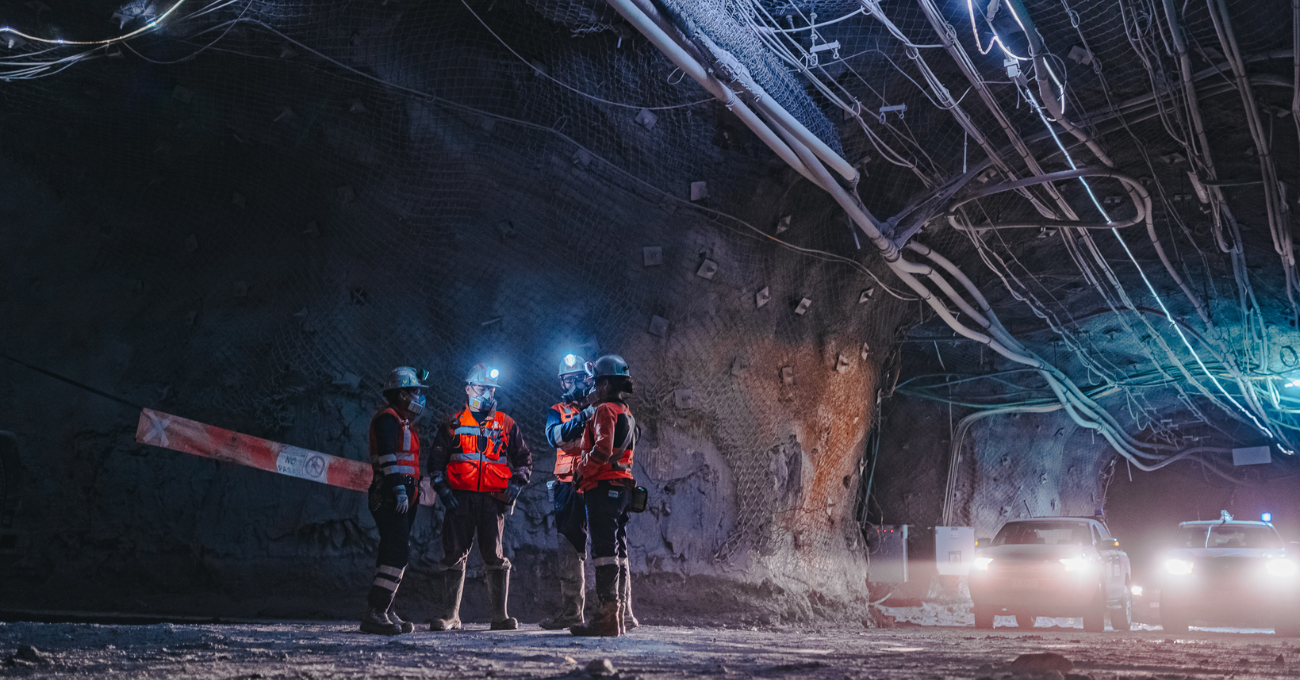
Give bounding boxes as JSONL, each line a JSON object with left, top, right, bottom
{"left": 429, "top": 364, "right": 533, "bottom": 631}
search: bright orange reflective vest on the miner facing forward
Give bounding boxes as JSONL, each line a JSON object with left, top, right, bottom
{"left": 447, "top": 407, "right": 515, "bottom": 493}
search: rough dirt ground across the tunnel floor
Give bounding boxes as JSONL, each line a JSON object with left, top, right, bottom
{"left": 0, "top": 619, "right": 1300, "bottom": 680}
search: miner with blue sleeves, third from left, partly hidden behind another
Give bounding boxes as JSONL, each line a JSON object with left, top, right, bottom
{"left": 540, "top": 354, "right": 595, "bottom": 631}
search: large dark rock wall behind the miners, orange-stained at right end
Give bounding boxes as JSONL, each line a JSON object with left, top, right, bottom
{"left": 0, "top": 1, "right": 902, "bottom": 629}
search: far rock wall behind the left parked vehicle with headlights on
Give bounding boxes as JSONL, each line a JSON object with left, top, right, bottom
{"left": 867, "top": 395, "right": 1112, "bottom": 597}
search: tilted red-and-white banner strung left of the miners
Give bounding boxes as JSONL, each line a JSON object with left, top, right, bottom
{"left": 135, "top": 408, "right": 373, "bottom": 491}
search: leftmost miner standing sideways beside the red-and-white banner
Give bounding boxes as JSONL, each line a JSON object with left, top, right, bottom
{"left": 361, "top": 367, "right": 426, "bottom": 634}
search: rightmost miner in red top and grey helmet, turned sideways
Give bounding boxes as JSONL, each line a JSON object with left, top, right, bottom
{"left": 569, "top": 354, "right": 637, "bottom": 637}
